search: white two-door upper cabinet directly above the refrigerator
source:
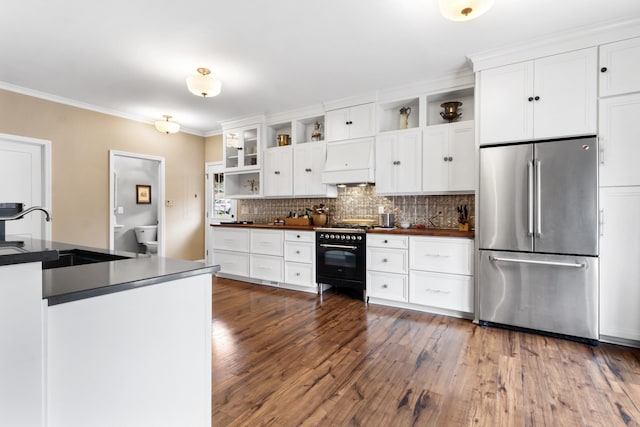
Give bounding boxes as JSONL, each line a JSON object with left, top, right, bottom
{"left": 479, "top": 47, "right": 598, "bottom": 144}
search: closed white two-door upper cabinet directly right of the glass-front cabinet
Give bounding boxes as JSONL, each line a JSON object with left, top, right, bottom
{"left": 263, "top": 145, "right": 293, "bottom": 197}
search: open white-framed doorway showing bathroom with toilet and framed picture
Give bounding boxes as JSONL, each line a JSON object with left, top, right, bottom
{"left": 109, "top": 150, "right": 165, "bottom": 256}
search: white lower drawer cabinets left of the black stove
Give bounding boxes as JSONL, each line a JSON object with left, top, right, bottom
{"left": 212, "top": 226, "right": 317, "bottom": 292}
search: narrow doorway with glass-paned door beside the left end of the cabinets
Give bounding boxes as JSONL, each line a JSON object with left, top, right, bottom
{"left": 204, "top": 162, "right": 237, "bottom": 264}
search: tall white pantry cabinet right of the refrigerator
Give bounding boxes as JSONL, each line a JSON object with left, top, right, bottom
{"left": 599, "top": 38, "right": 640, "bottom": 345}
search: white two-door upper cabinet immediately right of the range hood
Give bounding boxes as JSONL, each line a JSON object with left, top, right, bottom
{"left": 376, "top": 129, "right": 422, "bottom": 194}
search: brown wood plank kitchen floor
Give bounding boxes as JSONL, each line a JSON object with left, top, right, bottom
{"left": 212, "top": 278, "right": 640, "bottom": 426}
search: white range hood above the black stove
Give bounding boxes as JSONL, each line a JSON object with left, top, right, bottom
{"left": 322, "top": 138, "right": 375, "bottom": 184}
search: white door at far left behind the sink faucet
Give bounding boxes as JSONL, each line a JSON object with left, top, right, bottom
{"left": 0, "top": 134, "right": 50, "bottom": 240}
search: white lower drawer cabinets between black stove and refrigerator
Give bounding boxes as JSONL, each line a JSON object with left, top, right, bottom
{"left": 367, "top": 234, "right": 474, "bottom": 317}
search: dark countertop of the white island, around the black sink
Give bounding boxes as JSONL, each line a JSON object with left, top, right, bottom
{"left": 0, "top": 239, "right": 220, "bottom": 305}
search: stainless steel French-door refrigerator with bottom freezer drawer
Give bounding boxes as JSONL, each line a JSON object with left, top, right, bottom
{"left": 476, "top": 137, "right": 598, "bottom": 340}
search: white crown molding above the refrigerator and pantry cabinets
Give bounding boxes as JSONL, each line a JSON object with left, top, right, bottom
{"left": 467, "top": 19, "right": 640, "bottom": 72}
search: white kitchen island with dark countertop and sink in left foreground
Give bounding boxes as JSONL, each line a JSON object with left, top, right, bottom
{"left": 0, "top": 240, "right": 218, "bottom": 426}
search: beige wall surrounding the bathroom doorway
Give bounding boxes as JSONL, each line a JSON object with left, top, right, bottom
{"left": 0, "top": 90, "right": 205, "bottom": 259}
